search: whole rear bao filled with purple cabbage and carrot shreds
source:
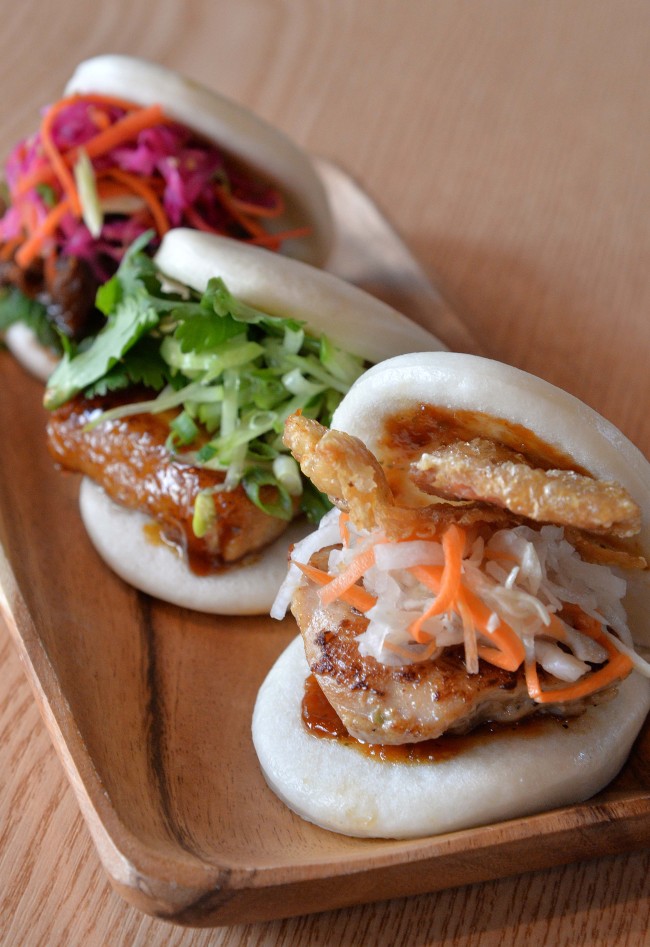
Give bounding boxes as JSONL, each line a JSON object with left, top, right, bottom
{"left": 0, "top": 55, "right": 333, "bottom": 380}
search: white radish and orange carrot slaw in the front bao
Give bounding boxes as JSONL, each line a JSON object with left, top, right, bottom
{"left": 271, "top": 510, "right": 650, "bottom": 703}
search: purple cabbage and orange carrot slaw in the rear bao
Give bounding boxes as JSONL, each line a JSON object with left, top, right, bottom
{"left": 0, "top": 94, "right": 306, "bottom": 279}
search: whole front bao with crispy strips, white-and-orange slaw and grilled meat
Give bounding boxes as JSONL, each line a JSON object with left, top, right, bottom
{"left": 252, "top": 352, "right": 650, "bottom": 838}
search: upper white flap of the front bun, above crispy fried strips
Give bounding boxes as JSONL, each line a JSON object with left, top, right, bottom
{"left": 332, "top": 352, "right": 650, "bottom": 647}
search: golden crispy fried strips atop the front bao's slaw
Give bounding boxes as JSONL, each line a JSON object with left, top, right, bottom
{"left": 284, "top": 414, "right": 647, "bottom": 569}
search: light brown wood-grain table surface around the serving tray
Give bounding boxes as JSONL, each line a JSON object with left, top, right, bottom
{"left": 0, "top": 0, "right": 650, "bottom": 945}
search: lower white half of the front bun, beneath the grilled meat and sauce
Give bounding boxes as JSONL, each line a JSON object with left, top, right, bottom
{"left": 253, "top": 637, "right": 650, "bottom": 838}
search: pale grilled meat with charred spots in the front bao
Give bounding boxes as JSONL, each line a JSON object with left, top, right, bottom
{"left": 291, "top": 550, "right": 614, "bottom": 744}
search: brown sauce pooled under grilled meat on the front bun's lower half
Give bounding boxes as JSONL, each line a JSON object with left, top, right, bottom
{"left": 302, "top": 674, "right": 569, "bottom": 763}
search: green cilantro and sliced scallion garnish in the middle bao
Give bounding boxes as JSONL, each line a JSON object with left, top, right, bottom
{"left": 44, "top": 233, "right": 365, "bottom": 524}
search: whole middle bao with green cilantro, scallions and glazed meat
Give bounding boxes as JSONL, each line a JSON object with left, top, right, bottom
{"left": 45, "top": 229, "right": 442, "bottom": 614}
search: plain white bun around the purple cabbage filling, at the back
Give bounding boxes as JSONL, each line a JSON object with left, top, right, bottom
{"left": 6, "top": 54, "right": 333, "bottom": 381}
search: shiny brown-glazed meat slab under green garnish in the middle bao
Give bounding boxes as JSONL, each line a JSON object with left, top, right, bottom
{"left": 47, "top": 392, "right": 286, "bottom": 571}
